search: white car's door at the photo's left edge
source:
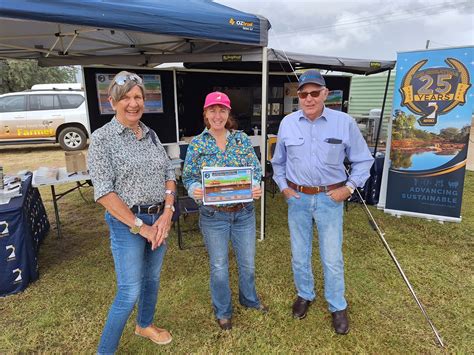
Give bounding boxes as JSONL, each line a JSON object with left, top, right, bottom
{"left": 0, "top": 95, "right": 27, "bottom": 140}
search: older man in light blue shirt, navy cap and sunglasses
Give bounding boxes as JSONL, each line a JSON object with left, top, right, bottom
{"left": 272, "top": 69, "right": 373, "bottom": 334}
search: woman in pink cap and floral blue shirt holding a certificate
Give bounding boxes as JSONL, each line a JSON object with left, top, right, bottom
{"left": 183, "top": 91, "right": 268, "bottom": 330}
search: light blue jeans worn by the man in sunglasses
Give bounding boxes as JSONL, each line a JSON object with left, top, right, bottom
{"left": 287, "top": 192, "right": 347, "bottom": 312}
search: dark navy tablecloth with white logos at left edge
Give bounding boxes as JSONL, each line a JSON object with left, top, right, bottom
{"left": 0, "top": 175, "right": 49, "bottom": 296}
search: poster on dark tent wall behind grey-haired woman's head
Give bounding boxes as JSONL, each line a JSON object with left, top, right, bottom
{"left": 95, "top": 73, "right": 163, "bottom": 115}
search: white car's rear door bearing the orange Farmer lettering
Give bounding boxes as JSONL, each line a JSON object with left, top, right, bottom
{"left": 27, "top": 94, "right": 64, "bottom": 139}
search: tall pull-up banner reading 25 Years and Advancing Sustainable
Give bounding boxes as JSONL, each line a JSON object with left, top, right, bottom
{"left": 385, "top": 47, "right": 474, "bottom": 222}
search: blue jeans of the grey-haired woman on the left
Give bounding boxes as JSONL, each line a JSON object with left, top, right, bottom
{"left": 97, "top": 212, "right": 166, "bottom": 354}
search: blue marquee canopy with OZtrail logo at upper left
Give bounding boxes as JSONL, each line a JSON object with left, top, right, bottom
{"left": 0, "top": 0, "right": 270, "bottom": 66}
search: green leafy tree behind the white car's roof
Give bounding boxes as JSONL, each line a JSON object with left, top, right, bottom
{"left": 0, "top": 59, "right": 76, "bottom": 94}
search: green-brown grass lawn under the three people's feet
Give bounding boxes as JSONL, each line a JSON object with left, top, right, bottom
{"left": 0, "top": 146, "right": 474, "bottom": 354}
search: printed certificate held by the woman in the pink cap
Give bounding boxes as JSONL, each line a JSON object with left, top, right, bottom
{"left": 202, "top": 167, "right": 253, "bottom": 205}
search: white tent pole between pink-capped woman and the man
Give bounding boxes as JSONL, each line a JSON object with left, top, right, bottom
{"left": 260, "top": 47, "right": 268, "bottom": 240}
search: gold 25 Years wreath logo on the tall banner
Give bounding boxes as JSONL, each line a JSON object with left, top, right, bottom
{"left": 400, "top": 58, "right": 471, "bottom": 126}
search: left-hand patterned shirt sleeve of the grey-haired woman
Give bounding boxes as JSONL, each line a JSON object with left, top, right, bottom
{"left": 87, "top": 131, "right": 115, "bottom": 201}
